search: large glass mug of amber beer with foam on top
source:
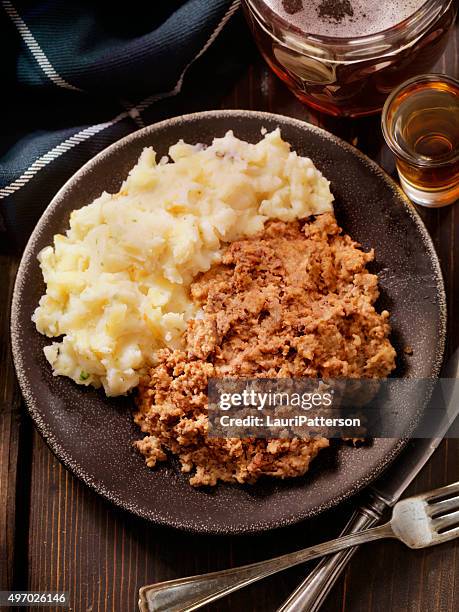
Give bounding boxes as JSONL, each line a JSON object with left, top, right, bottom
{"left": 243, "top": 0, "right": 457, "bottom": 117}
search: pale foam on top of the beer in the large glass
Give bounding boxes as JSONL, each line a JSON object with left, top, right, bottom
{"left": 265, "top": 0, "right": 426, "bottom": 37}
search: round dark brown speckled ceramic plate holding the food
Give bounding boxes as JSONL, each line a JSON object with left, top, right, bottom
{"left": 12, "top": 111, "right": 445, "bottom": 533}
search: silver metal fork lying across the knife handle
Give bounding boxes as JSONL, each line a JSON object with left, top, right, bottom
{"left": 139, "top": 482, "right": 459, "bottom": 612}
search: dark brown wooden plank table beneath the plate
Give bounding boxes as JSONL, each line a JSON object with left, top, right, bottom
{"left": 0, "top": 15, "right": 459, "bottom": 612}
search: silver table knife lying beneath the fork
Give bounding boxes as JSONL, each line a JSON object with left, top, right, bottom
{"left": 277, "top": 349, "right": 459, "bottom": 612}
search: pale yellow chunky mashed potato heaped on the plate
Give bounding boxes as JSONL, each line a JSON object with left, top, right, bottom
{"left": 33, "top": 130, "right": 333, "bottom": 395}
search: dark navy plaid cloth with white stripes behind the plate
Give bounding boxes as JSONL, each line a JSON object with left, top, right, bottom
{"left": 0, "top": 0, "right": 253, "bottom": 248}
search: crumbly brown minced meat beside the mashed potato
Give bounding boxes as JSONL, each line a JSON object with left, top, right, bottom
{"left": 135, "top": 213, "right": 396, "bottom": 485}
